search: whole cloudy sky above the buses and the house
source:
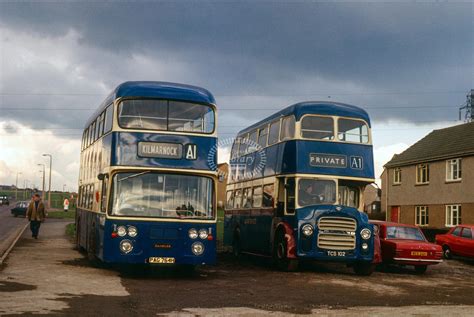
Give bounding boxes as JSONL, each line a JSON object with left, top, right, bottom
{"left": 0, "top": 1, "right": 474, "bottom": 190}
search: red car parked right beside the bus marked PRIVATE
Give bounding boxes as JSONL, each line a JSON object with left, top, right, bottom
{"left": 371, "top": 221, "right": 443, "bottom": 274}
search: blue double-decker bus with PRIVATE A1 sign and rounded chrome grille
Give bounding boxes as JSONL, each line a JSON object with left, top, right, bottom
{"left": 224, "top": 102, "right": 374, "bottom": 275}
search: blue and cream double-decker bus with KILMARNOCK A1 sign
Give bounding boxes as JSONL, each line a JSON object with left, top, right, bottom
{"left": 76, "top": 82, "right": 217, "bottom": 266}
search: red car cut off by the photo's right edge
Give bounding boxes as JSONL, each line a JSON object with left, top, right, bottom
{"left": 436, "top": 225, "right": 474, "bottom": 259}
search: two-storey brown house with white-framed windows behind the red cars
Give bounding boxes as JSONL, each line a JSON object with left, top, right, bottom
{"left": 381, "top": 122, "right": 474, "bottom": 229}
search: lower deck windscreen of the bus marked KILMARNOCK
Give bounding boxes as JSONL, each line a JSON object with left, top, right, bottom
{"left": 111, "top": 172, "right": 214, "bottom": 219}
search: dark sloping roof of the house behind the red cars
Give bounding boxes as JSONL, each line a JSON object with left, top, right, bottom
{"left": 385, "top": 122, "right": 474, "bottom": 167}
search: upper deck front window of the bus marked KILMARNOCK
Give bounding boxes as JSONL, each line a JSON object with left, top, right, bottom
{"left": 118, "top": 99, "right": 214, "bottom": 133}
